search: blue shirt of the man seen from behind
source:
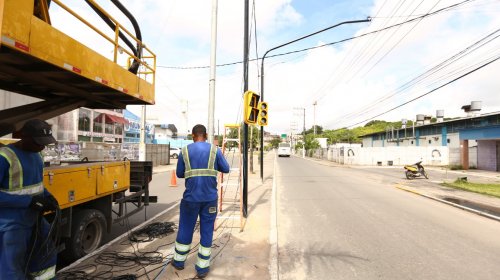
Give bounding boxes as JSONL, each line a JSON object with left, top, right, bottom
{"left": 176, "top": 142, "right": 229, "bottom": 202}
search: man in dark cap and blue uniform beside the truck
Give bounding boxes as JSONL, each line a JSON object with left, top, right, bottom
{"left": 0, "top": 119, "right": 58, "bottom": 280}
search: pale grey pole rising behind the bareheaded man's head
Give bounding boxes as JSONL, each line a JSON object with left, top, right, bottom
{"left": 207, "top": 0, "right": 217, "bottom": 144}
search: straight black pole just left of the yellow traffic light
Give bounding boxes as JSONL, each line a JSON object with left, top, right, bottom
{"left": 243, "top": 0, "right": 250, "bottom": 218}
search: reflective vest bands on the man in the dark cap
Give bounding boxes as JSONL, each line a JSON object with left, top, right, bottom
{"left": 0, "top": 147, "right": 43, "bottom": 195}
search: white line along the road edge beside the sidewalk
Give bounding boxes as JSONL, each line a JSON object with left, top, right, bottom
{"left": 269, "top": 154, "right": 279, "bottom": 280}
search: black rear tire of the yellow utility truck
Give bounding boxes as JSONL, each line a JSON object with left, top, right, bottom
{"left": 64, "top": 209, "right": 106, "bottom": 260}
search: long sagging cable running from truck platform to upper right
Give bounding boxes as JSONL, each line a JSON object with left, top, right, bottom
{"left": 156, "top": 0, "right": 476, "bottom": 70}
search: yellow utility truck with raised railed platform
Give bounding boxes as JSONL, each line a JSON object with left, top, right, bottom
{"left": 0, "top": 0, "right": 156, "bottom": 259}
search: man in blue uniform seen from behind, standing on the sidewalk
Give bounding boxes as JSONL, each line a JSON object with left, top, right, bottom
{"left": 172, "top": 124, "right": 229, "bottom": 278}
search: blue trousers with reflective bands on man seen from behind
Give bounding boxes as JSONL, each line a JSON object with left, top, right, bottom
{"left": 174, "top": 199, "right": 217, "bottom": 274}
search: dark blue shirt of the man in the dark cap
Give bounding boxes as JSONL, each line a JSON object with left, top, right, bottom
{"left": 0, "top": 145, "right": 48, "bottom": 232}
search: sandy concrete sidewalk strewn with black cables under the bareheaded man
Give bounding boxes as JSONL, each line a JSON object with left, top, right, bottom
{"left": 57, "top": 152, "right": 275, "bottom": 280}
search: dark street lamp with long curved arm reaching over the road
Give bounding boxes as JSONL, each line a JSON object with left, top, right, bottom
{"left": 260, "top": 18, "right": 371, "bottom": 180}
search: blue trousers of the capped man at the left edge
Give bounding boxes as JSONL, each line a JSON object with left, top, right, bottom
{"left": 0, "top": 219, "right": 57, "bottom": 280}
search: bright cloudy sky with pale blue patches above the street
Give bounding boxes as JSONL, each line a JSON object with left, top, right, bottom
{"left": 51, "top": 0, "right": 500, "bottom": 134}
